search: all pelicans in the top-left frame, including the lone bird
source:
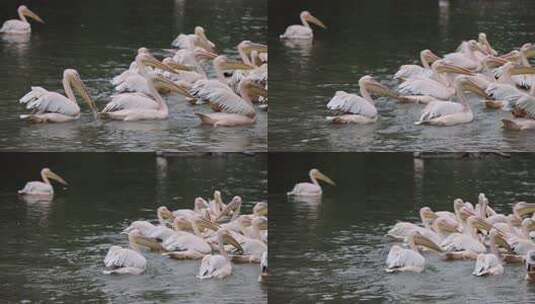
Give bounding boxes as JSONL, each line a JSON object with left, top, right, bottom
{"left": 4, "top": 6, "right": 268, "bottom": 127}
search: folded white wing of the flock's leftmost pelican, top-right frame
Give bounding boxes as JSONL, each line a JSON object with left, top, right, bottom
{"left": 327, "top": 91, "right": 377, "bottom": 117}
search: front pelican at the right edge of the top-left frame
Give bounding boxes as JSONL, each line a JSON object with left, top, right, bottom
{"left": 195, "top": 79, "right": 267, "bottom": 127}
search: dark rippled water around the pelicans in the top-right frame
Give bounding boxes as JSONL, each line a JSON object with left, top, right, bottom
{"left": 269, "top": 0, "right": 535, "bottom": 151}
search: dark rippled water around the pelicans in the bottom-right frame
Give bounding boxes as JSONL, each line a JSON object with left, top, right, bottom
{"left": 269, "top": 153, "right": 535, "bottom": 303}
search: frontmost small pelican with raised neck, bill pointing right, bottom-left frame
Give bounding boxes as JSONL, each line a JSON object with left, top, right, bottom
{"left": 197, "top": 229, "right": 241, "bottom": 280}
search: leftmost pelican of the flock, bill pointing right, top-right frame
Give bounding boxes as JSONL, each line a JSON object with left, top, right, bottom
{"left": 326, "top": 75, "right": 406, "bottom": 124}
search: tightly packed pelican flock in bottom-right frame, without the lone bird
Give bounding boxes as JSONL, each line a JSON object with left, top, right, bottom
{"left": 386, "top": 193, "right": 535, "bottom": 281}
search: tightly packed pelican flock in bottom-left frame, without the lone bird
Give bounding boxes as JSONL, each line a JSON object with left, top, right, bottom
{"left": 104, "top": 191, "right": 268, "bottom": 281}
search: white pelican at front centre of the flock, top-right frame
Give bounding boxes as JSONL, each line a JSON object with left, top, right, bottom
{"left": 414, "top": 76, "right": 480, "bottom": 126}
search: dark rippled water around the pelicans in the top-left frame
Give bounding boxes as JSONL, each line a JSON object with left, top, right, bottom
{"left": 0, "top": 0, "right": 267, "bottom": 152}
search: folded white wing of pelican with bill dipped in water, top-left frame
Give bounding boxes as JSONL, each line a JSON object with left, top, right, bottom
{"left": 19, "top": 87, "right": 80, "bottom": 116}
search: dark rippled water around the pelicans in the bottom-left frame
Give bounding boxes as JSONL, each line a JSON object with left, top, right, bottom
{"left": 0, "top": 153, "right": 267, "bottom": 303}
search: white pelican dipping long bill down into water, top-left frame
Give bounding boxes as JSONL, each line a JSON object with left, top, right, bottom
{"left": 20, "top": 69, "right": 97, "bottom": 123}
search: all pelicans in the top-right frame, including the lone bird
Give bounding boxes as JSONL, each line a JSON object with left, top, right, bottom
{"left": 280, "top": 11, "right": 535, "bottom": 130}
